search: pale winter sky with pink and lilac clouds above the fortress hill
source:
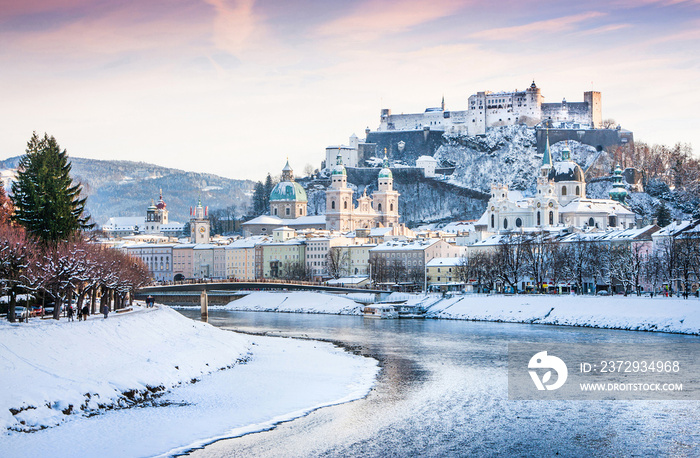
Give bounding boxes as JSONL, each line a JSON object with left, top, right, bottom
{"left": 0, "top": 0, "right": 700, "bottom": 180}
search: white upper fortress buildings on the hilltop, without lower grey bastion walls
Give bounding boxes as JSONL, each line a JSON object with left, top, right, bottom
{"left": 377, "top": 81, "right": 603, "bottom": 136}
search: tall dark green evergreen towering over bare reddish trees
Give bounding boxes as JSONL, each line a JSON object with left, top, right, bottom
{"left": 12, "top": 132, "right": 93, "bottom": 242}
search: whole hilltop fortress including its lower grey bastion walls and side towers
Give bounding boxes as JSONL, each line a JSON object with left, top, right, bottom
{"left": 344, "top": 81, "right": 634, "bottom": 167}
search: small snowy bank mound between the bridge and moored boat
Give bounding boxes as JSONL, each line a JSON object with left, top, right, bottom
{"left": 216, "top": 291, "right": 362, "bottom": 315}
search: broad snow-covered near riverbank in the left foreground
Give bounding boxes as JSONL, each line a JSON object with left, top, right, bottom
{"left": 0, "top": 307, "right": 378, "bottom": 457}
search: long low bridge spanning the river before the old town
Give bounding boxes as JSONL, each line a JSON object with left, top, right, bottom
{"left": 134, "top": 281, "right": 391, "bottom": 304}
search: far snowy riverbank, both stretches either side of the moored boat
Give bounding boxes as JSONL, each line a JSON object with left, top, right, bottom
{"left": 212, "top": 292, "right": 700, "bottom": 334}
